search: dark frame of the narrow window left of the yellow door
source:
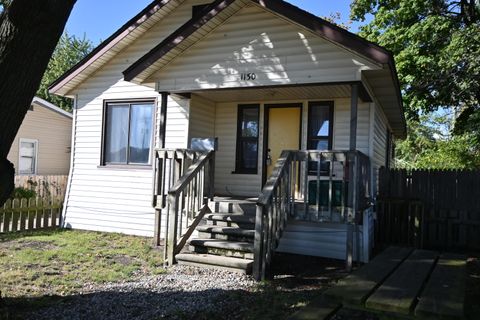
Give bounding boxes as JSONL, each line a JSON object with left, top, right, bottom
{"left": 233, "top": 104, "right": 260, "bottom": 174}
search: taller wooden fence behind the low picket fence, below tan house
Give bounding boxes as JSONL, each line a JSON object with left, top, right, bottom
{"left": 15, "top": 175, "right": 68, "bottom": 200}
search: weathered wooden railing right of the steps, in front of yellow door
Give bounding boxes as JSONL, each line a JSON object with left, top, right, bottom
{"left": 253, "top": 151, "right": 371, "bottom": 280}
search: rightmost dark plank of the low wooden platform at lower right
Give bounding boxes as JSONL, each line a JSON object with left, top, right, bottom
{"left": 415, "top": 254, "right": 467, "bottom": 319}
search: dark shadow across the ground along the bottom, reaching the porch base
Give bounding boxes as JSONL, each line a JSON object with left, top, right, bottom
{"left": 0, "top": 255, "right": 344, "bottom": 320}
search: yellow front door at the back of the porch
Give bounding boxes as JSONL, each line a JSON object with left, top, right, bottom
{"left": 267, "top": 105, "right": 302, "bottom": 179}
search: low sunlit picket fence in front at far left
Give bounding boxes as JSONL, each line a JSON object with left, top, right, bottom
{"left": 0, "top": 198, "right": 62, "bottom": 233}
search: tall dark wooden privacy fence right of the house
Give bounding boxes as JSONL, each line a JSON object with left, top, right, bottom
{"left": 377, "top": 168, "right": 480, "bottom": 250}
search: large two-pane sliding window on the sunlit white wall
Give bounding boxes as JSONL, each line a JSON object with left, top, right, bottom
{"left": 103, "top": 101, "right": 154, "bottom": 165}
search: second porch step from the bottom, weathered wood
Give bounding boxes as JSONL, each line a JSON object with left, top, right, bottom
{"left": 190, "top": 239, "right": 253, "bottom": 259}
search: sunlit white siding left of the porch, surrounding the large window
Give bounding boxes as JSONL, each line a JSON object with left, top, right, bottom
{"left": 64, "top": 0, "right": 205, "bottom": 236}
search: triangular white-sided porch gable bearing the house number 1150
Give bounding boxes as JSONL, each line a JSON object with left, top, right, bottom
{"left": 154, "top": 6, "right": 377, "bottom": 91}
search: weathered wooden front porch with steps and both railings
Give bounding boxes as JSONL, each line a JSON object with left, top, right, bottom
{"left": 153, "top": 149, "right": 373, "bottom": 279}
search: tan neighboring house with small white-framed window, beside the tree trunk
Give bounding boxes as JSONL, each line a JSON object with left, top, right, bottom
{"left": 8, "top": 97, "right": 72, "bottom": 175}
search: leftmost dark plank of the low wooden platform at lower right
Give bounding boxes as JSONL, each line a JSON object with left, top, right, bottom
{"left": 325, "top": 247, "right": 413, "bottom": 306}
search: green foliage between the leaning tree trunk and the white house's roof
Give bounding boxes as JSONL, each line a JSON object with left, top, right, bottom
{"left": 37, "top": 33, "right": 93, "bottom": 111}
